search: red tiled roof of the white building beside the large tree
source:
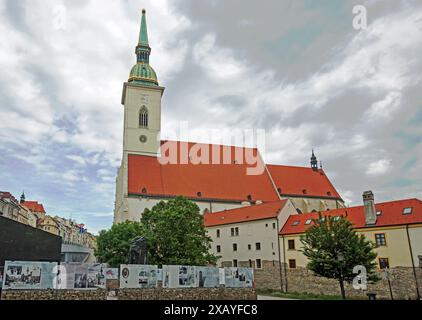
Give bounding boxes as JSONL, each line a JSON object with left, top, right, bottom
{"left": 204, "top": 200, "right": 288, "bottom": 227}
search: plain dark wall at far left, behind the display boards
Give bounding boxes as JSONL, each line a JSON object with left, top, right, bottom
{"left": 0, "top": 216, "right": 62, "bottom": 267}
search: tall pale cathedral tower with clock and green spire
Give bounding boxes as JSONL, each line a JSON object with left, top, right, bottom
{"left": 114, "top": 10, "right": 164, "bottom": 222}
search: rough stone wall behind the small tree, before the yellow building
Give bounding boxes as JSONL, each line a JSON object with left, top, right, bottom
{"left": 287, "top": 267, "right": 422, "bottom": 300}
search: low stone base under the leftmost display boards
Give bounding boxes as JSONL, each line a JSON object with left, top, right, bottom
{"left": 1, "top": 289, "right": 107, "bottom": 300}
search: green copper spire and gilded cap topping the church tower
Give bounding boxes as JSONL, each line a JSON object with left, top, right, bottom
{"left": 129, "top": 9, "right": 158, "bottom": 86}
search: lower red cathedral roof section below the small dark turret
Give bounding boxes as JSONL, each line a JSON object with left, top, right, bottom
{"left": 267, "top": 165, "right": 341, "bottom": 199}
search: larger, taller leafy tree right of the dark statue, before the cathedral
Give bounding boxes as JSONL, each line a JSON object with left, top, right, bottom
{"left": 141, "top": 197, "right": 217, "bottom": 266}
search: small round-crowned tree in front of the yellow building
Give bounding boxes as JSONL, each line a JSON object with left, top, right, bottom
{"left": 301, "top": 214, "right": 379, "bottom": 299}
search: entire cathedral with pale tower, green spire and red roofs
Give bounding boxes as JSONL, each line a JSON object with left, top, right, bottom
{"left": 114, "top": 10, "right": 344, "bottom": 223}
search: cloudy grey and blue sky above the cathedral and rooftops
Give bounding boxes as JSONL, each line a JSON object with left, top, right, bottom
{"left": 0, "top": 0, "right": 422, "bottom": 232}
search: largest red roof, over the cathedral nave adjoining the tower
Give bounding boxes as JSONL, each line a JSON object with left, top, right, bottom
{"left": 128, "top": 141, "right": 279, "bottom": 202}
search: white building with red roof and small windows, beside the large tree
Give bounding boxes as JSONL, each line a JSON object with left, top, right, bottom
{"left": 204, "top": 199, "right": 298, "bottom": 290}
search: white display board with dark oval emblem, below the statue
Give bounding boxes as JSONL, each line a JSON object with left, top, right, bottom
{"left": 120, "top": 265, "right": 158, "bottom": 289}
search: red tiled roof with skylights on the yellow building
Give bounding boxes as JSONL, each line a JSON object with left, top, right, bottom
{"left": 280, "top": 199, "right": 422, "bottom": 235}
